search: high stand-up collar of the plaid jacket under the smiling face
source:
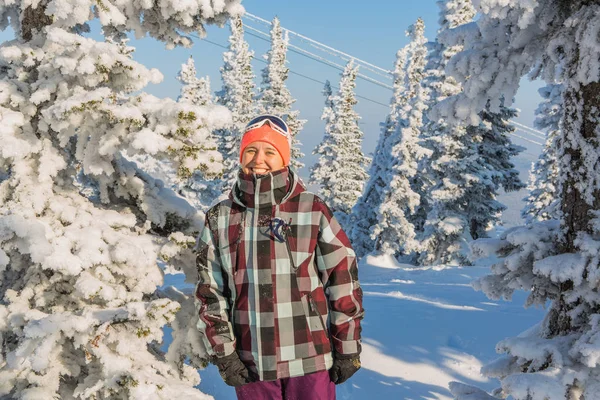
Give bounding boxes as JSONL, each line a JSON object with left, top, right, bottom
{"left": 230, "top": 167, "right": 299, "bottom": 208}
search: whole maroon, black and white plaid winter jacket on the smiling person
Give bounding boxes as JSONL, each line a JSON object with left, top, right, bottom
{"left": 195, "top": 168, "right": 364, "bottom": 381}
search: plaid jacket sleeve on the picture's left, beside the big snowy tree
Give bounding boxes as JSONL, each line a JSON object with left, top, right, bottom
{"left": 195, "top": 210, "right": 236, "bottom": 358}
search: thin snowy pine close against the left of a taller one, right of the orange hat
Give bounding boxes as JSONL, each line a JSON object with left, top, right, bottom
{"left": 308, "top": 80, "right": 335, "bottom": 198}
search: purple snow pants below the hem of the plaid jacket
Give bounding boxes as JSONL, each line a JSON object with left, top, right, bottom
{"left": 235, "top": 371, "right": 335, "bottom": 400}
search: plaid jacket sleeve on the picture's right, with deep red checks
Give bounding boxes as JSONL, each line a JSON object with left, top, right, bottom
{"left": 316, "top": 203, "right": 364, "bottom": 355}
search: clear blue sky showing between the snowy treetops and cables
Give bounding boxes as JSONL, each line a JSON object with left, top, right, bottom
{"left": 0, "top": 0, "right": 541, "bottom": 176}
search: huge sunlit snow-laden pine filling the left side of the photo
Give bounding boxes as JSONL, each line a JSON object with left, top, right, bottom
{"left": 0, "top": 0, "right": 243, "bottom": 399}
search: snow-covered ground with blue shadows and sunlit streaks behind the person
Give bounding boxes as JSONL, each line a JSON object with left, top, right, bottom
{"left": 167, "top": 248, "right": 543, "bottom": 400}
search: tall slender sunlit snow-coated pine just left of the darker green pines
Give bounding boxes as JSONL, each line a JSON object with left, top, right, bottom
{"left": 372, "top": 18, "right": 430, "bottom": 257}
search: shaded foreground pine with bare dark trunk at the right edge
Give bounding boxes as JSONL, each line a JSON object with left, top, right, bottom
{"left": 434, "top": 0, "right": 600, "bottom": 400}
